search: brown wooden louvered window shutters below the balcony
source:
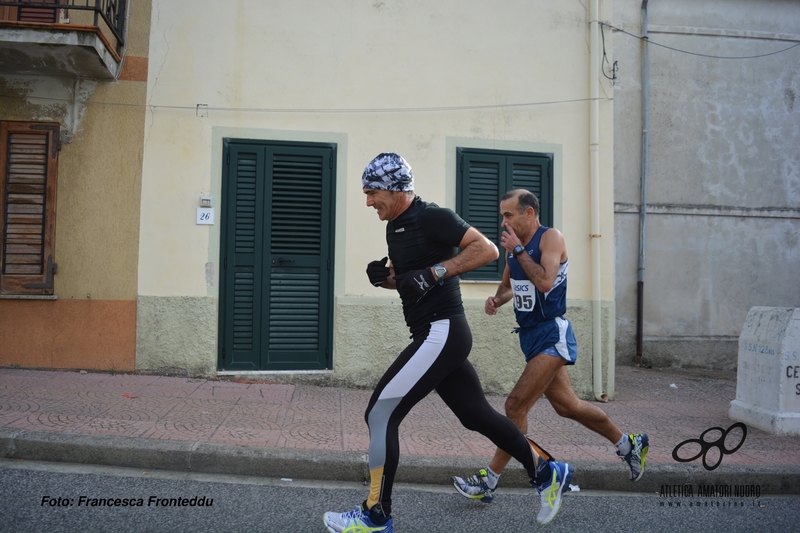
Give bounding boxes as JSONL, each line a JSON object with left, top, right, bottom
{"left": 0, "top": 122, "right": 59, "bottom": 294}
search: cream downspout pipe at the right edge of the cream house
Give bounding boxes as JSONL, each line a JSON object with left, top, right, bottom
{"left": 589, "top": 0, "right": 608, "bottom": 402}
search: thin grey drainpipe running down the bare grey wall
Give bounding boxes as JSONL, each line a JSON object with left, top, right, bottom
{"left": 634, "top": 0, "right": 650, "bottom": 366}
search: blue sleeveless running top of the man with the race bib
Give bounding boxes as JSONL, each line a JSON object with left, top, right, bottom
{"left": 507, "top": 226, "right": 569, "bottom": 328}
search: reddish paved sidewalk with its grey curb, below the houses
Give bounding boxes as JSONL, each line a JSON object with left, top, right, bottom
{"left": 0, "top": 367, "right": 800, "bottom": 495}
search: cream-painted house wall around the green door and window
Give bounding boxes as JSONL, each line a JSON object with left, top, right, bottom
{"left": 137, "top": 0, "right": 614, "bottom": 394}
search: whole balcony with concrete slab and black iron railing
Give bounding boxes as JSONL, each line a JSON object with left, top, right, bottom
{"left": 0, "top": 0, "right": 127, "bottom": 80}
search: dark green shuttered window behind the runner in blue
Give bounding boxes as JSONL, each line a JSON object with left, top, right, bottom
{"left": 456, "top": 144, "right": 553, "bottom": 281}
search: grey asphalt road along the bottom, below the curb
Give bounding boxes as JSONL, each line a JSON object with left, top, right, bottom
{"left": 0, "top": 459, "right": 800, "bottom": 533}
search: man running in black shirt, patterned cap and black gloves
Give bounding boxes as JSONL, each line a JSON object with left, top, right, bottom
{"left": 323, "top": 156, "right": 573, "bottom": 533}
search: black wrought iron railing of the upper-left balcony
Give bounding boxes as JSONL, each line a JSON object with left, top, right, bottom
{"left": 0, "top": 0, "right": 128, "bottom": 53}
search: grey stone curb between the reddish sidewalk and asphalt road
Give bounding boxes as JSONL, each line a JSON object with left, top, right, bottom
{"left": 0, "top": 428, "right": 800, "bottom": 496}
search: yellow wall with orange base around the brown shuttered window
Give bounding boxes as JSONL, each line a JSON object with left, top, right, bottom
{"left": 0, "top": 1, "right": 150, "bottom": 370}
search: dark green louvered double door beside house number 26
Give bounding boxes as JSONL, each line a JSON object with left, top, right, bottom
{"left": 220, "top": 139, "right": 335, "bottom": 371}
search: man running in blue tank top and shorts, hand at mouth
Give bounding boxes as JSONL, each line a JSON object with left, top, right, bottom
{"left": 452, "top": 189, "right": 649, "bottom": 503}
